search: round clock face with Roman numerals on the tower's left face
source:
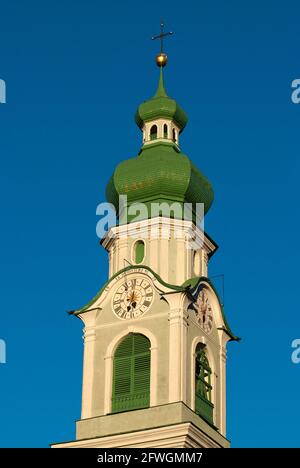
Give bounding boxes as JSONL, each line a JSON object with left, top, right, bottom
{"left": 112, "top": 278, "right": 154, "bottom": 320}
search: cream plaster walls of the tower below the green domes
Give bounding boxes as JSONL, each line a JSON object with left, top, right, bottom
{"left": 55, "top": 225, "right": 230, "bottom": 447}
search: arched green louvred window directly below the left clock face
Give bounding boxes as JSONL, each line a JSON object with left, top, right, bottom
{"left": 112, "top": 333, "right": 150, "bottom": 413}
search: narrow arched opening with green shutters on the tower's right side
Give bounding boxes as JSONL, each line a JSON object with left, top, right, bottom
{"left": 195, "top": 343, "right": 214, "bottom": 424}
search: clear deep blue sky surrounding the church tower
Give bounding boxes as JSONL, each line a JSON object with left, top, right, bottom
{"left": 0, "top": 0, "right": 300, "bottom": 447}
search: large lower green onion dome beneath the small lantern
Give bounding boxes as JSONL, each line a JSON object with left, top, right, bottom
{"left": 106, "top": 143, "right": 214, "bottom": 222}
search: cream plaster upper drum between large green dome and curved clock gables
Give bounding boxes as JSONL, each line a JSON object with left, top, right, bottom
{"left": 102, "top": 216, "right": 217, "bottom": 285}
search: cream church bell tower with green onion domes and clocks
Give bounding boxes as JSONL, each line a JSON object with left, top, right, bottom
{"left": 52, "top": 26, "right": 238, "bottom": 448}
